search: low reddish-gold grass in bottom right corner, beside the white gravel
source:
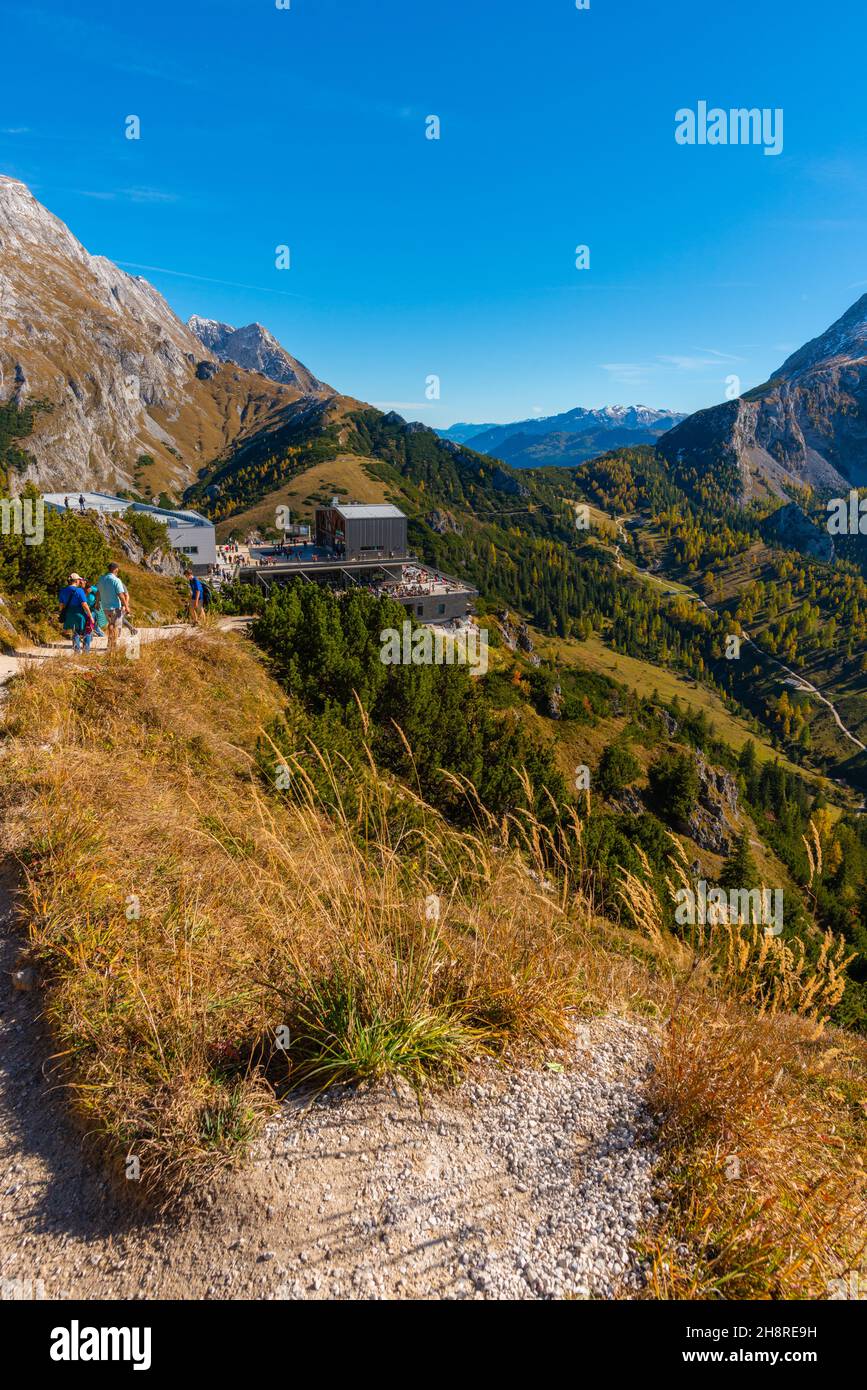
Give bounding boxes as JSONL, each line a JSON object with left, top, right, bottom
{"left": 647, "top": 990, "right": 867, "bottom": 1300}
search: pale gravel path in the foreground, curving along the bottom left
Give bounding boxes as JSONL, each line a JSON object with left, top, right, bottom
{"left": 0, "top": 872, "right": 654, "bottom": 1298}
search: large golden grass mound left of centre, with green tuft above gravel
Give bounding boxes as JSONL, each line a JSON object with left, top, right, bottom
{"left": 6, "top": 632, "right": 589, "bottom": 1191}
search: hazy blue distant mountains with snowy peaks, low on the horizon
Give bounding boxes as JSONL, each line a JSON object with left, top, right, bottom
{"left": 438, "top": 406, "right": 685, "bottom": 468}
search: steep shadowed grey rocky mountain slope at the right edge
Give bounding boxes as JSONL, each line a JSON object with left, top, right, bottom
{"left": 659, "top": 295, "right": 867, "bottom": 502}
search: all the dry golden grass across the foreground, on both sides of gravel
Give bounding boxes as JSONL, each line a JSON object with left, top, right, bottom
{"left": 3, "top": 631, "right": 867, "bottom": 1298}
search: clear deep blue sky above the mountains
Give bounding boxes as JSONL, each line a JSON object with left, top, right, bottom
{"left": 0, "top": 0, "right": 867, "bottom": 424}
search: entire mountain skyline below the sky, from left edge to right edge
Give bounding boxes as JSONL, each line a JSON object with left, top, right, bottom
{"left": 0, "top": 175, "right": 867, "bottom": 522}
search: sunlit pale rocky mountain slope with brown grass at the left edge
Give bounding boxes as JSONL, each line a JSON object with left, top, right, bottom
{"left": 0, "top": 177, "right": 329, "bottom": 493}
